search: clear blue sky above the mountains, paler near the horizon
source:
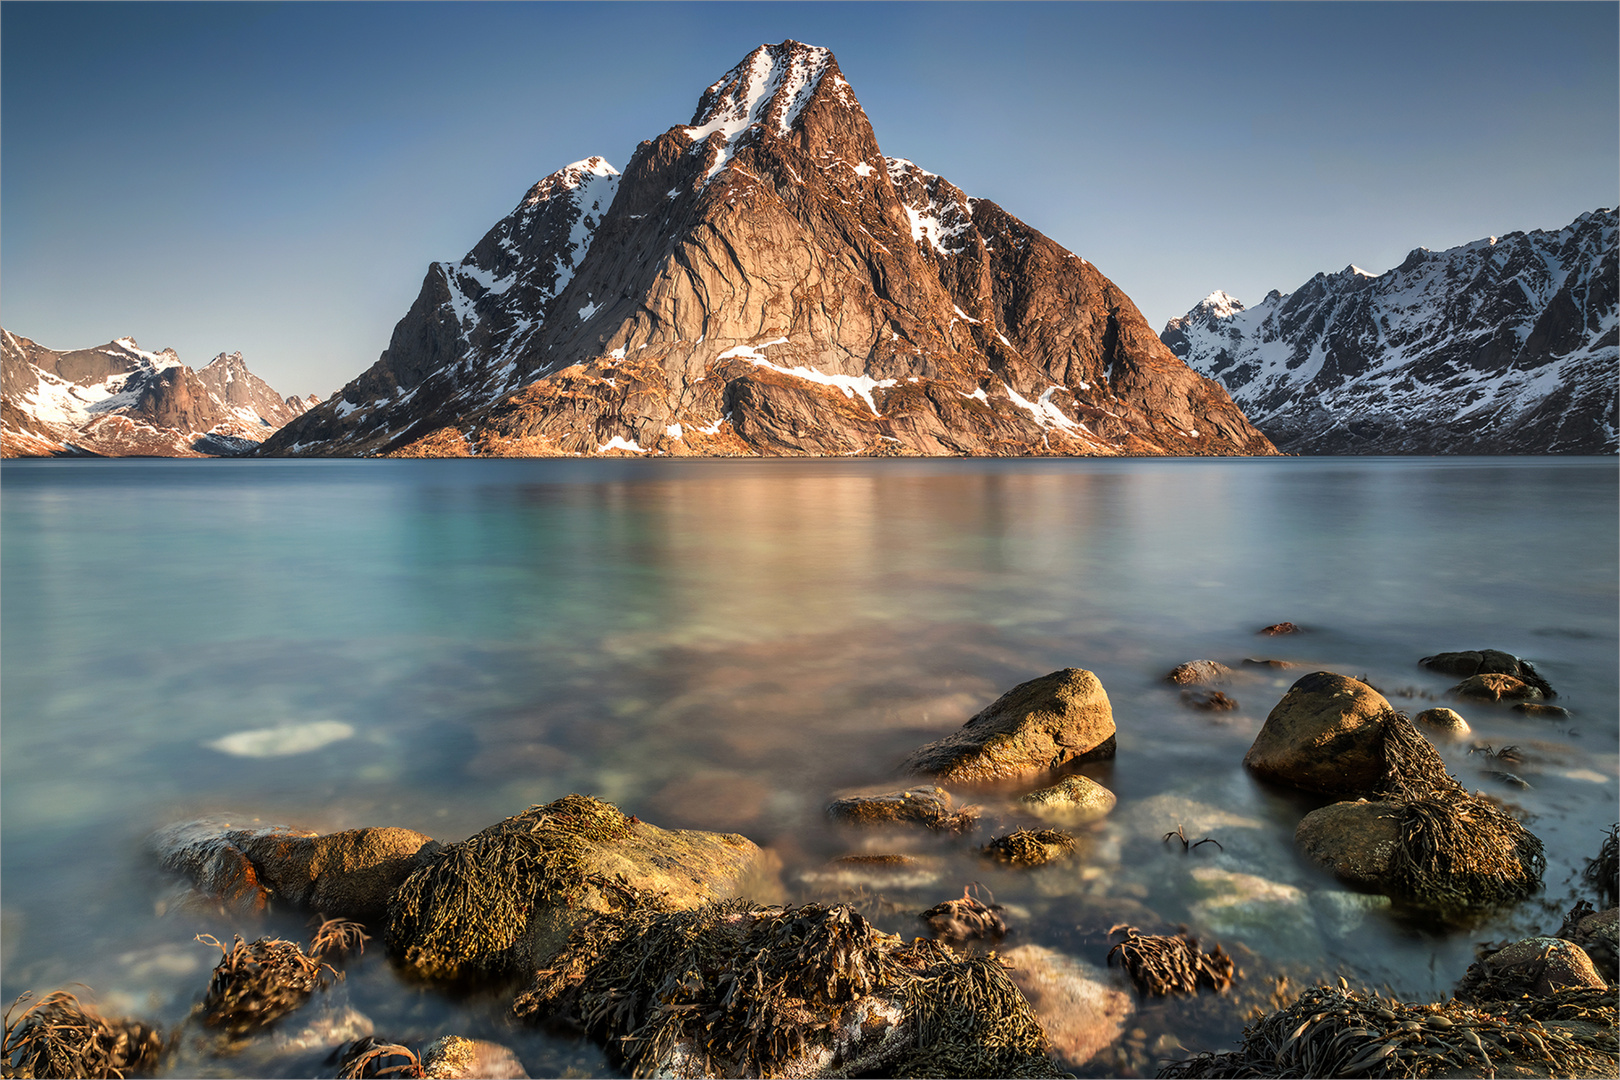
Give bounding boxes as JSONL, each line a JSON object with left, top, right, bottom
{"left": 0, "top": 0, "right": 1620, "bottom": 397}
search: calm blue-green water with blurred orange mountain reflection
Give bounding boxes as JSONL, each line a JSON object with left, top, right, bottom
{"left": 0, "top": 458, "right": 1620, "bottom": 1075}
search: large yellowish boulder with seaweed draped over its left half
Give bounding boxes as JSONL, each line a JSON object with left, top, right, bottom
{"left": 387, "top": 795, "right": 779, "bottom": 978}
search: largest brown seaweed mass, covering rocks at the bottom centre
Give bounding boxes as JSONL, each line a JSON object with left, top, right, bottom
{"left": 512, "top": 899, "right": 1061, "bottom": 1077}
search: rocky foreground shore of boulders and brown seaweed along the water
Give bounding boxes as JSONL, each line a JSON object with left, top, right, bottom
{"left": 0, "top": 647, "right": 1620, "bottom": 1077}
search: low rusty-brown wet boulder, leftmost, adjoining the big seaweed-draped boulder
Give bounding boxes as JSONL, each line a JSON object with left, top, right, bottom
{"left": 149, "top": 818, "right": 437, "bottom": 920}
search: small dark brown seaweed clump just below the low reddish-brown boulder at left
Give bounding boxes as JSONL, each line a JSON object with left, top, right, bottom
{"left": 196, "top": 934, "right": 342, "bottom": 1038}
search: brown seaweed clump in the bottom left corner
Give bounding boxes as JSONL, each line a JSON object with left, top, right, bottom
{"left": 0, "top": 989, "right": 165, "bottom": 1077}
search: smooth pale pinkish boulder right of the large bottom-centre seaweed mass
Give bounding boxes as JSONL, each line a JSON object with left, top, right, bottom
{"left": 1001, "top": 946, "right": 1136, "bottom": 1065}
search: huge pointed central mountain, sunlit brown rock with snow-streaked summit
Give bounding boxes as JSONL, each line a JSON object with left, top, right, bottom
{"left": 261, "top": 40, "right": 1275, "bottom": 455}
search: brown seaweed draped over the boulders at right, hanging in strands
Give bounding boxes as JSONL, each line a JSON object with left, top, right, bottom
{"left": 1377, "top": 712, "right": 1547, "bottom": 910}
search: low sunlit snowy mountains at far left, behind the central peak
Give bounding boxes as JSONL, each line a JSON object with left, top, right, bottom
{"left": 0, "top": 330, "right": 316, "bottom": 458}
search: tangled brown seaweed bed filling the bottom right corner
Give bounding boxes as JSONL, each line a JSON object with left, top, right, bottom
{"left": 1158, "top": 980, "right": 1615, "bottom": 1077}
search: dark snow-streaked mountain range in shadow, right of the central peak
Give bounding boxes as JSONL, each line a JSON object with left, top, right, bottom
{"left": 1160, "top": 210, "right": 1620, "bottom": 453}
